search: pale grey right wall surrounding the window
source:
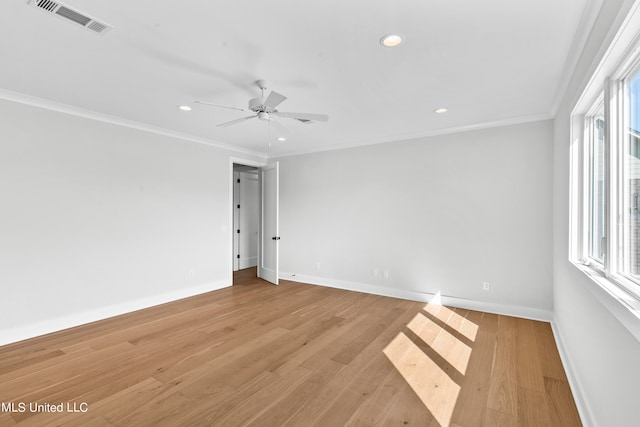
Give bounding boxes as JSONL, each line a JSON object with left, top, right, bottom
{"left": 553, "top": 0, "right": 640, "bottom": 427}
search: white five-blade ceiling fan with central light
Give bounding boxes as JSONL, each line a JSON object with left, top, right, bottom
{"left": 195, "top": 80, "right": 329, "bottom": 131}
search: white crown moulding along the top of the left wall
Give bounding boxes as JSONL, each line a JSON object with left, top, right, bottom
{"left": 0, "top": 89, "right": 267, "bottom": 159}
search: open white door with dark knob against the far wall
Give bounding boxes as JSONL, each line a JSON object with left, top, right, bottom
{"left": 258, "top": 162, "right": 280, "bottom": 285}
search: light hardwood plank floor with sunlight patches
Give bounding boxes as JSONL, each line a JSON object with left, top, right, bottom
{"left": 0, "top": 269, "right": 581, "bottom": 427}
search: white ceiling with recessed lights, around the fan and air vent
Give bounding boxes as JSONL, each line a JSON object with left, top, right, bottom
{"left": 0, "top": 0, "right": 592, "bottom": 156}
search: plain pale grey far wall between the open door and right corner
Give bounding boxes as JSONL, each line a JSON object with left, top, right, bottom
{"left": 280, "top": 121, "right": 553, "bottom": 317}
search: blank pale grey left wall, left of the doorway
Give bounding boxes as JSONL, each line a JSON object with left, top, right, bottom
{"left": 0, "top": 101, "right": 258, "bottom": 343}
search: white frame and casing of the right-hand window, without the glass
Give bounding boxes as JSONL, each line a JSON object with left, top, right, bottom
{"left": 569, "top": 33, "right": 640, "bottom": 328}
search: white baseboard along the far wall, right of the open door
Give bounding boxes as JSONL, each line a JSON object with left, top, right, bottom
{"left": 280, "top": 271, "right": 553, "bottom": 322}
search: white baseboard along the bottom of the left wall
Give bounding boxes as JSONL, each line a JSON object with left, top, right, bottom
{"left": 0, "top": 280, "right": 231, "bottom": 345}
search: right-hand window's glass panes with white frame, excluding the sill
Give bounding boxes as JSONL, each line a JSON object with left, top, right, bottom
{"left": 571, "top": 49, "right": 640, "bottom": 306}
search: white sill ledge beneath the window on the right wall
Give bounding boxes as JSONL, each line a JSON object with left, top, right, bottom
{"left": 572, "top": 261, "right": 640, "bottom": 341}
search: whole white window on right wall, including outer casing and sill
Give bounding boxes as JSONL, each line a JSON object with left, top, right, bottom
{"left": 569, "top": 0, "right": 640, "bottom": 341}
